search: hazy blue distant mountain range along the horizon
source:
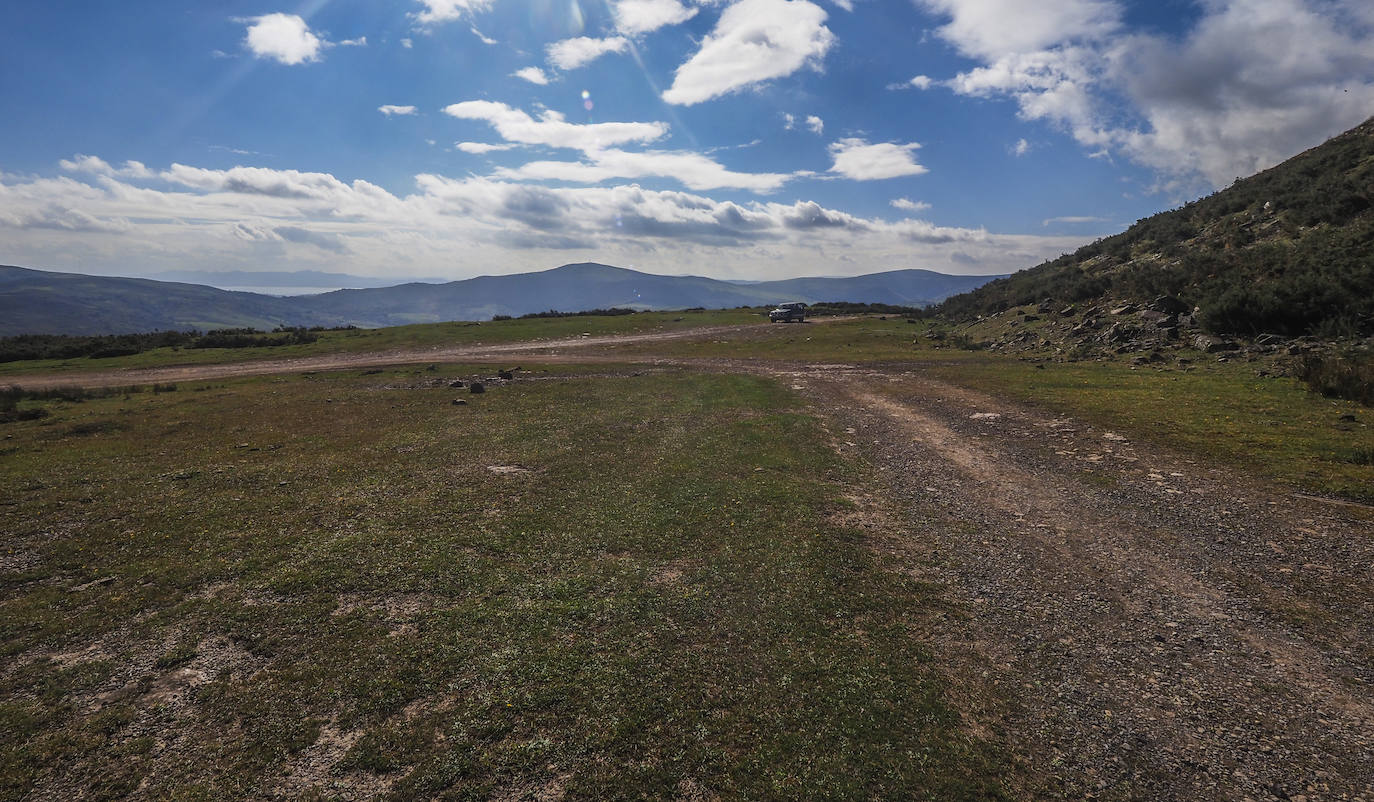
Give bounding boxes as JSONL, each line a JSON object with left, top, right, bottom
{"left": 0, "top": 262, "right": 999, "bottom": 336}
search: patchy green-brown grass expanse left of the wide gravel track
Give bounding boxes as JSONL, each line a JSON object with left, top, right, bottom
{"left": 0, "top": 365, "right": 1006, "bottom": 799}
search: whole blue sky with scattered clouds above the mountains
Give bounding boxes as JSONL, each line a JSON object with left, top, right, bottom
{"left": 0, "top": 0, "right": 1374, "bottom": 280}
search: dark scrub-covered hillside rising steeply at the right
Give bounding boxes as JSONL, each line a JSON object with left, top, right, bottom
{"left": 937, "top": 118, "right": 1374, "bottom": 336}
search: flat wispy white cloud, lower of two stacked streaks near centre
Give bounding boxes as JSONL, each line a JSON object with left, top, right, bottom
{"left": 496, "top": 150, "right": 791, "bottom": 192}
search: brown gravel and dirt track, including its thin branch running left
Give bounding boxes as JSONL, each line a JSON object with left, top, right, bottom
{"left": 13, "top": 327, "right": 1374, "bottom": 801}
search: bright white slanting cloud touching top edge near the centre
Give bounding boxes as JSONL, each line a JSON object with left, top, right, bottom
{"left": 664, "top": 0, "right": 835, "bottom": 106}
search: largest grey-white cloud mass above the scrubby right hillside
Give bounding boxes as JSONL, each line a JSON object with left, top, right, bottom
{"left": 921, "top": 0, "right": 1374, "bottom": 188}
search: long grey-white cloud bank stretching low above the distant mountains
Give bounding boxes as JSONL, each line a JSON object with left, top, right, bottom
{"left": 0, "top": 154, "right": 1087, "bottom": 279}
